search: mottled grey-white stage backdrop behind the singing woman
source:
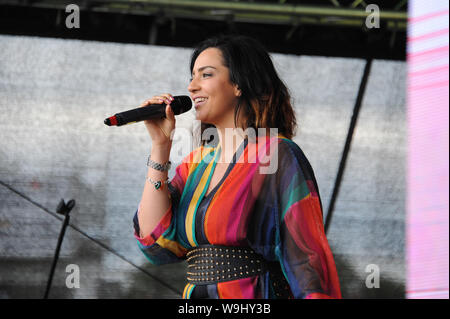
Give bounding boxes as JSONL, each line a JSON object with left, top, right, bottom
{"left": 0, "top": 36, "right": 406, "bottom": 298}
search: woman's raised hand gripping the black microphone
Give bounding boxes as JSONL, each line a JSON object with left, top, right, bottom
{"left": 140, "top": 93, "right": 175, "bottom": 146}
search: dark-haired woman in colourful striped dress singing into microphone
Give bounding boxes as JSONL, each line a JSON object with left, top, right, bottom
{"left": 134, "top": 36, "right": 341, "bottom": 298}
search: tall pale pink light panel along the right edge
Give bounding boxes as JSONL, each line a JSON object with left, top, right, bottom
{"left": 406, "top": 0, "right": 449, "bottom": 299}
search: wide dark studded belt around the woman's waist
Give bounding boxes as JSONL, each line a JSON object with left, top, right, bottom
{"left": 186, "top": 245, "right": 271, "bottom": 285}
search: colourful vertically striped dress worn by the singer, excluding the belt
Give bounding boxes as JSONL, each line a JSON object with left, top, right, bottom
{"left": 133, "top": 135, "right": 341, "bottom": 299}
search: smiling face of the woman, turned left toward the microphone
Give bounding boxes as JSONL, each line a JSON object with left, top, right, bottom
{"left": 188, "top": 48, "right": 240, "bottom": 127}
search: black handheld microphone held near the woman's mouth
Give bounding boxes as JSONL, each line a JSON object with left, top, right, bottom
{"left": 104, "top": 95, "right": 192, "bottom": 126}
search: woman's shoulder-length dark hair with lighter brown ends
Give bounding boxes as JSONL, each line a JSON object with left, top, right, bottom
{"left": 190, "top": 35, "right": 297, "bottom": 145}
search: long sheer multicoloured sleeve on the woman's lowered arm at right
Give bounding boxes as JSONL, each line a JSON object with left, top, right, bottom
{"left": 275, "top": 139, "right": 341, "bottom": 299}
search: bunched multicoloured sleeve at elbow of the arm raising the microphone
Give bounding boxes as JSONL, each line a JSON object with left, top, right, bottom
{"left": 133, "top": 160, "right": 189, "bottom": 265}
